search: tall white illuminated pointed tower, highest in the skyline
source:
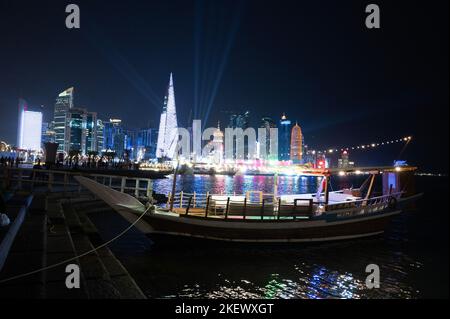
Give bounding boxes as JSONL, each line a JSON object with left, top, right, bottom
{"left": 156, "top": 73, "right": 178, "bottom": 159}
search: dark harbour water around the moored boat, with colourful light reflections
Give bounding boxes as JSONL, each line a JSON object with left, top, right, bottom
{"left": 89, "top": 176, "right": 448, "bottom": 298}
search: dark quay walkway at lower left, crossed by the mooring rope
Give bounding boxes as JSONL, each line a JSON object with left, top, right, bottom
{"left": 0, "top": 193, "right": 145, "bottom": 299}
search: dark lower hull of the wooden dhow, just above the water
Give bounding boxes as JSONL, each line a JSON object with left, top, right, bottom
{"left": 144, "top": 211, "right": 400, "bottom": 243}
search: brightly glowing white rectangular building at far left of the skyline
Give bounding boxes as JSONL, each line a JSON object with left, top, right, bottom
{"left": 17, "top": 99, "right": 42, "bottom": 152}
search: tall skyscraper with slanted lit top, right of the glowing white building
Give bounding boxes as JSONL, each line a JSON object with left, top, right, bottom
{"left": 53, "top": 87, "right": 74, "bottom": 154}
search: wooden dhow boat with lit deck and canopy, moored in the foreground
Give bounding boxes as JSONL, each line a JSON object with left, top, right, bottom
{"left": 75, "top": 166, "right": 421, "bottom": 243}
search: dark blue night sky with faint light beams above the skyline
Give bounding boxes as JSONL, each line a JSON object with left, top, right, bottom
{"left": 0, "top": 0, "right": 449, "bottom": 172}
